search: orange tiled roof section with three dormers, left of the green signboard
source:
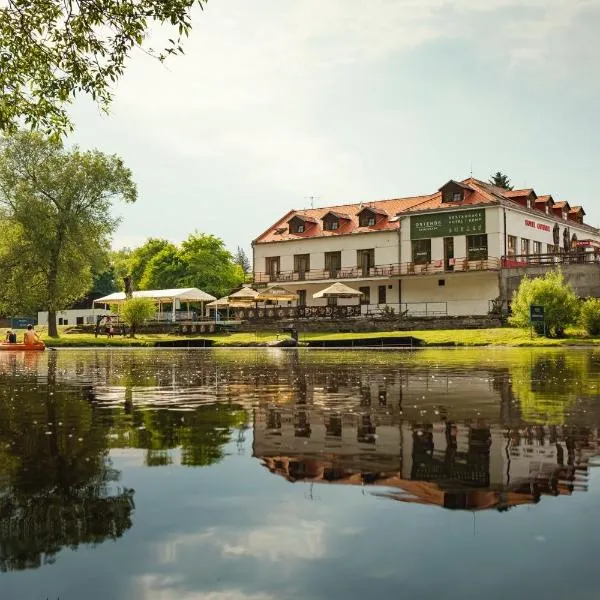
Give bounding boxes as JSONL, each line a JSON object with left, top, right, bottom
{"left": 254, "top": 196, "right": 431, "bottom": 244}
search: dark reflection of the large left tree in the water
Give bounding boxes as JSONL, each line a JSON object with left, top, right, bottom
{"left": 0, "top": 361, "right": 134, "bottom": 571}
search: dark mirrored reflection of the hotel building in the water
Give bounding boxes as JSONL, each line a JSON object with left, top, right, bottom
{"left": 254, "top": 405, "right": 599, "bottom": 510}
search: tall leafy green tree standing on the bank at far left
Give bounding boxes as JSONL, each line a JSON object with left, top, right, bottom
{"left": 0, "top": 132, "right": 137, "bottom": 337}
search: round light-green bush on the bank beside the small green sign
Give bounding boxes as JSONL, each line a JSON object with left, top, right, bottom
{"left": 509, "top": 271, "right": 579, "bottom": 337}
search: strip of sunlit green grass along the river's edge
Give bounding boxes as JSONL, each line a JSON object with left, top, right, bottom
{"left": 8, "top": 327, "right": 600, "bottom": 348}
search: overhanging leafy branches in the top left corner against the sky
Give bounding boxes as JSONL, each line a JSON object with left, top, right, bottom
{"left": 0, "top": 0, "right": 207, "bottom": 133}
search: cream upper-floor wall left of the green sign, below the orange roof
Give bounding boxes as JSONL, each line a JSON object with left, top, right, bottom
{"left": 254, "top": 230, "right": 399, "bottom": 273}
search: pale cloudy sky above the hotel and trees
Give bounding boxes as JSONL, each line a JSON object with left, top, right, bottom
{"left": 71, "top": 0, "right": 600, "bottom": 251}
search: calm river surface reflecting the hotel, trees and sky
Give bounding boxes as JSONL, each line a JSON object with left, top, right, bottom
{"left": 0, "top": 349, "right": 600, "bottom": 600}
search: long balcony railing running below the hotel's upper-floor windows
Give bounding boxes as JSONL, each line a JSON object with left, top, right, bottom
{"left": 254, "top": 258, "right": 501, "bottom": 283}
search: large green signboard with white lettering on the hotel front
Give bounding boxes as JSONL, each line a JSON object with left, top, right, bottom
{"left": 410, "top": 208, "right": 485, "bottom": 240}
